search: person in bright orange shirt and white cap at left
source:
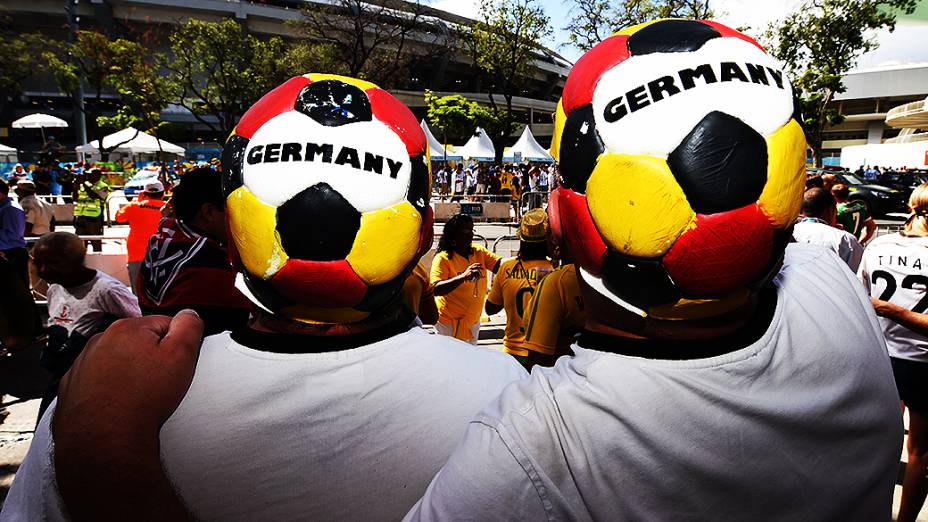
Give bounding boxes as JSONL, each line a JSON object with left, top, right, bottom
{"left": 115, "top": 180, "right": 164, "bottom": 294}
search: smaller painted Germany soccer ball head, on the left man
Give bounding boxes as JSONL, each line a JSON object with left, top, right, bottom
{"left": 222, "top": 74, "right": 432, "bottom": 323}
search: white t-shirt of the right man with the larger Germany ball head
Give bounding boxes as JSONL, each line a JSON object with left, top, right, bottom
{"left": 409, "top": 245, "right": 903, "bottom": 522}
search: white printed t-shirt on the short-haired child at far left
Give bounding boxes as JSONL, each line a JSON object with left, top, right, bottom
{"left": 48, "top": 270, "right": 142, "bottom": 335}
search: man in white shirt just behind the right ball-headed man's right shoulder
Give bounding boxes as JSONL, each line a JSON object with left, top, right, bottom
{"left": 793, "top": 188, "right": 864, "bottom": 272}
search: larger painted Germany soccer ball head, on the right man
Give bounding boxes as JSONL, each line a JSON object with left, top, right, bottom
{"left": 552, "top": 20, "right": 806, "bottom": 319}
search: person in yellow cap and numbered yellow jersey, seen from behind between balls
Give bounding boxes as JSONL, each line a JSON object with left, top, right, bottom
{"left": 486, "top": 208, "right": 554, "bottom": 365}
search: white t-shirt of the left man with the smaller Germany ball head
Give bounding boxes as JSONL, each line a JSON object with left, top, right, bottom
{"left": 0, "top": 328, "right": 526, "bottom": 521}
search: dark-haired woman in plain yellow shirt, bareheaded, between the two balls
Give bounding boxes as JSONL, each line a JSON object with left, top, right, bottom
{"left": 429, "top": 214, "right": 501, "bottom": 344}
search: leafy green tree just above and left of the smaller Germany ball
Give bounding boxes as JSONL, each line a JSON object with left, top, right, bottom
{"left": 163, "top": 19, "right": 288, "bottom": 143}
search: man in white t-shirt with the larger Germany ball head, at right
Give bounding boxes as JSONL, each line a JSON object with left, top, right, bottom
{"left": 408, "top": 20, "right": 903, "bottom": 521}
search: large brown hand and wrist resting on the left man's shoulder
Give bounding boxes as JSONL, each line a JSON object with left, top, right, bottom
{"left": 52, "top": 310, "right": 203, "bottom": 520}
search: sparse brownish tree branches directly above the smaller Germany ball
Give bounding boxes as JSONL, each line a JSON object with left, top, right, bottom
{"left": 293, "top": 0, "right": 452, "bottom": 88}
